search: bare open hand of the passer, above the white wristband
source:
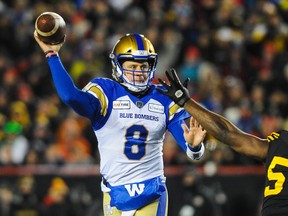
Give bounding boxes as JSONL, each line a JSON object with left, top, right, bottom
{"left": 181, "top": 116, "right": 206, "bottom": 148}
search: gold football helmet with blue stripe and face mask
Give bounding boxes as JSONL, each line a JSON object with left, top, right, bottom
{"left": 110, "top": 34, "right": 158, "bottom": 92}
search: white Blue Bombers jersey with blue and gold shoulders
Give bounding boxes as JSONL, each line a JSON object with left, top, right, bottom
{"left": 84, "top": 78, "right": 190, "bottom": 186}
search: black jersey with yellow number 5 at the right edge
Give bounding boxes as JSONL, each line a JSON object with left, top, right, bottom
{"left": 262, "top": 130, "right": 288, "bottom": 216}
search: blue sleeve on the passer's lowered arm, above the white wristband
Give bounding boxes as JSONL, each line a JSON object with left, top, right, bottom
{"left": 168, "top": 120, "right": 187, "bottom": 152}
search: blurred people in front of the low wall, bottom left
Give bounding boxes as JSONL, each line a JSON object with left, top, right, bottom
{"left": 0, "top": 175, "right": 103, "bottom": 216}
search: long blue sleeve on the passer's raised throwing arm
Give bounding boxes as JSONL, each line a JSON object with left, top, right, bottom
{"left": 48, "top": 56, "right": 101, "bottom": 119}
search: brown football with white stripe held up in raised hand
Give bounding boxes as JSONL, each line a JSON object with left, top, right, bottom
{"left": 35, "top": 12, "right": 66, "bottom": 44}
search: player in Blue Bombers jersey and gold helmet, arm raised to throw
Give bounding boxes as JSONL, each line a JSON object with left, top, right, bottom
{"left": 34, "top": 33, "right": 206, "bottom": 216}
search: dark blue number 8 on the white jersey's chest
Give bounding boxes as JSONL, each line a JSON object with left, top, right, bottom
{"left": 124, "top": 125, "right": 148, "bottom": 160}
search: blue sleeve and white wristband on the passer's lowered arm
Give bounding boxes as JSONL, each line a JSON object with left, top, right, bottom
{"left": 168, "top": 120, "right": 205, "bottom": 160}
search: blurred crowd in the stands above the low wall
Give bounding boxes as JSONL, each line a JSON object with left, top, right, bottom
{"left": 0, "top": 0, "right": 288, "bottom": 170}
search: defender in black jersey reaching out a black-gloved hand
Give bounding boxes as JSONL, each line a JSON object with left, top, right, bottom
{"left": 158, "top": 69, "right": 288, "bottom": 216}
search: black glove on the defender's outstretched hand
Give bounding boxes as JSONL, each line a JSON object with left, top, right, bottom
{"left": 157, "top": 68, "right": 190, "bottom": 107}
